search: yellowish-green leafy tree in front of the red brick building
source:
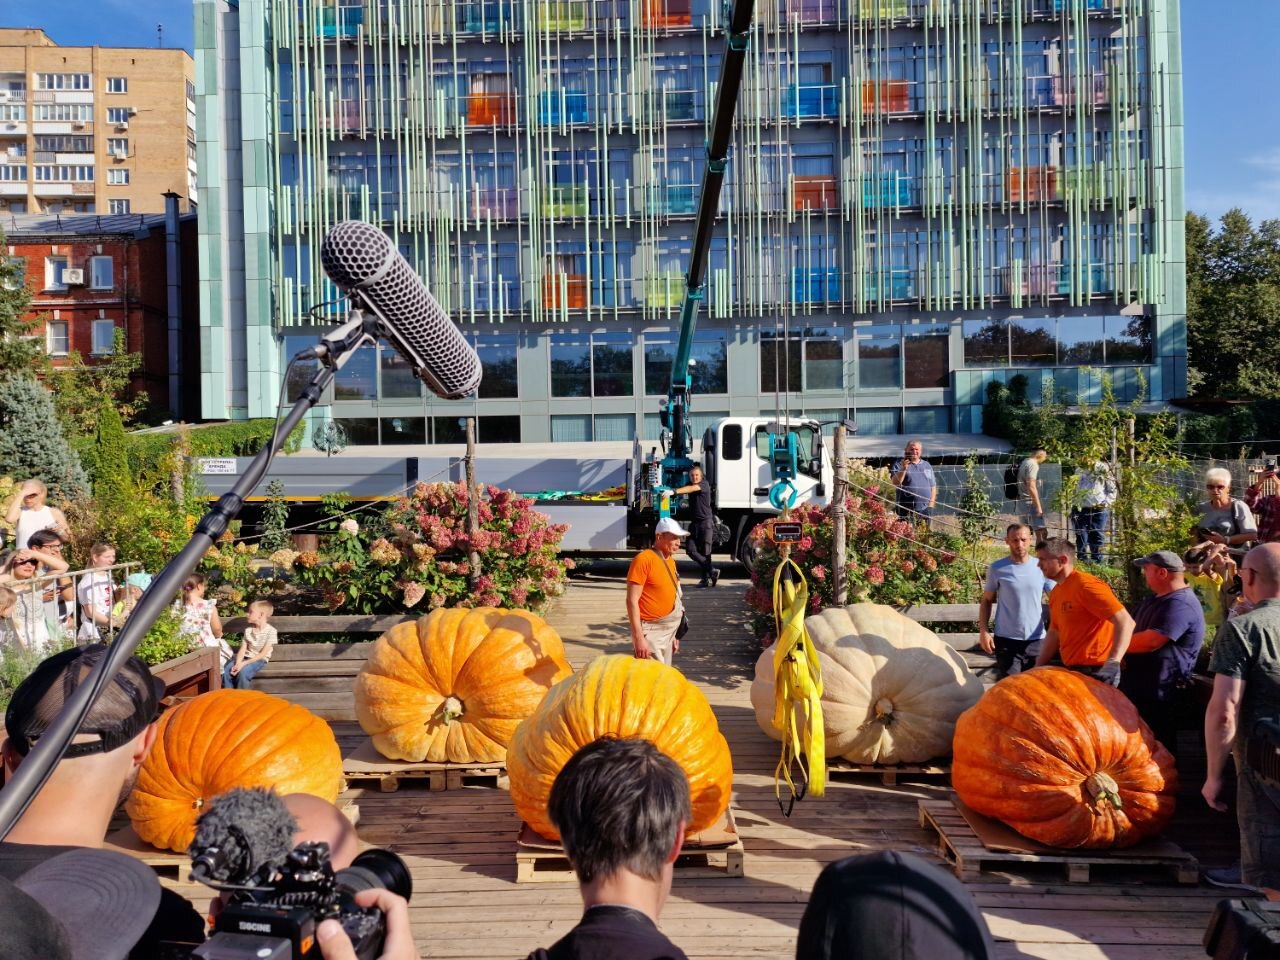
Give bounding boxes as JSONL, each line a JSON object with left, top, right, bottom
{"left": 47, "top": 329, "right": 148, "bottom": 436}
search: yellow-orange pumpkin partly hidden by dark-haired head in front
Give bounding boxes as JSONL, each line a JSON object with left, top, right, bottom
{"left": 507, "top": 654, "right": 733, "bottom": 840}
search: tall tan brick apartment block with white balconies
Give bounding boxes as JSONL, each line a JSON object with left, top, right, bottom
{"left": 0, "top": 28, "right": 196, "bottom": 214}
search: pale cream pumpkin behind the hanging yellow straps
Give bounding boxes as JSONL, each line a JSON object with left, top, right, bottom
{"left": 751, "top": 603, "right": 982, "bottom": 764}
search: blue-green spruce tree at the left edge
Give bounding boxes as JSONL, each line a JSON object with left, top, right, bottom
{"left": 0, "top": 376, "right": 88, "bottom": 500}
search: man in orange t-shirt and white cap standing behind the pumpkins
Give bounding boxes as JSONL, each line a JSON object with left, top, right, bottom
{"left": 627, "top": 517, "right": 689, "bottom": 664}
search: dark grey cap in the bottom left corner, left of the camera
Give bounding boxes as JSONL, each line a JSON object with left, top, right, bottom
{"left": 0, "top": 850, "right": 160, "bottom": 960}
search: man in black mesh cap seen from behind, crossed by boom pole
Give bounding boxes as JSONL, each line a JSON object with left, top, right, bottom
{"left": 0, "top": 644, "right": 205, "bottom": 957}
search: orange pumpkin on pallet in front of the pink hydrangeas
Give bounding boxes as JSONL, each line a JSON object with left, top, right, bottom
{"left": 356, "top": 607, "right": 571, "bottom": 763}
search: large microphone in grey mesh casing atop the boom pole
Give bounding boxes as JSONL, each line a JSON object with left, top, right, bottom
{"left": 320, "top": 220, "right": 481, "bottom": 399}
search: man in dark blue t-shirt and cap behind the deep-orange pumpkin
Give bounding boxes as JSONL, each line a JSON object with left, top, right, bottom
{"left": 1120, "top": 550, "right": 1204, "bottom": 755}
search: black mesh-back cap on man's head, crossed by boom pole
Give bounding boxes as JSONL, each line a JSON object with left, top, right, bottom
{"left": 4, "top": 644, "right": 164, "bottom": 758}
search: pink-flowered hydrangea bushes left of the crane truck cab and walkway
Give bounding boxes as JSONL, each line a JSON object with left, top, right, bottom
{"left": 205, "top": 483, "right": 573, "bottom": 613}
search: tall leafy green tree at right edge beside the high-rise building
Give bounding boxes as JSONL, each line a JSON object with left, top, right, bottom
{"left": 1187, "top": 209, "right": 1280, "bottom": 399}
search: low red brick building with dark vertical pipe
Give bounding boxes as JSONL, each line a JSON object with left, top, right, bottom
{"left": 0, "top": 196, "right": 200, "bottom": 419}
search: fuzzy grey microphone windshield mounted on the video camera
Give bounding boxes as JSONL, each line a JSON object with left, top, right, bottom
{"left": 187, "top": 787, "right": 298, "bottom": 884}
